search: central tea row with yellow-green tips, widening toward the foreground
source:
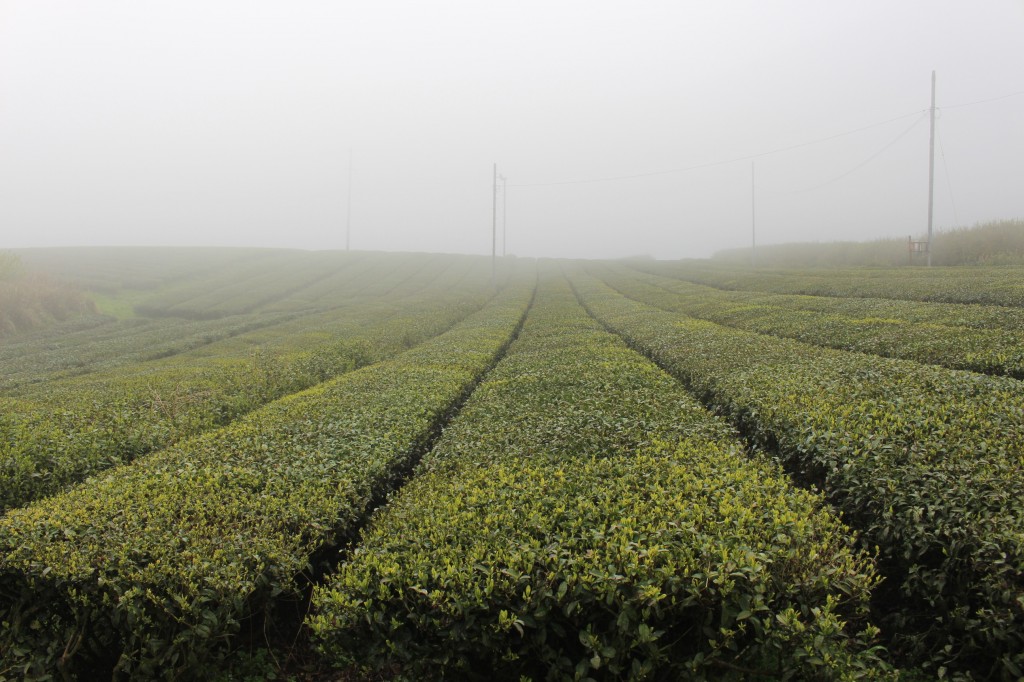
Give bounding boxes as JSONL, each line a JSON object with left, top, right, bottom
{"left": 309, "top": 279, "right": 885, "bottom": 680}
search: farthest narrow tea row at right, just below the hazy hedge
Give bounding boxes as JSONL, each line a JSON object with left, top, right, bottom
{"left": 630, "top": 260, "right": 1024, "bottom": 308}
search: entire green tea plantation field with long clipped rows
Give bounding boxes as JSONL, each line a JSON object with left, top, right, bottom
{"left": 0, "top": 249, "right": 1024, "bottom": 681}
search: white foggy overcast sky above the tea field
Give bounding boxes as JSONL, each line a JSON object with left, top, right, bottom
{"left": 0, "top": 0, "right": 1024, "bottom": 258}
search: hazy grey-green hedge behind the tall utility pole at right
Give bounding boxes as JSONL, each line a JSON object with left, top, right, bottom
{"left": 712, "top": 218, "right": 1024, "bottom": 267}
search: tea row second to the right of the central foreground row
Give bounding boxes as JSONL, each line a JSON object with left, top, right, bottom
{"left": 590, "top": 265, "right": 1024, "bottom": 379}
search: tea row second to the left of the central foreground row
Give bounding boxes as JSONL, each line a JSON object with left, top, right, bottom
{"left": 0, "top": 261, "right": 487, "bottom": 509}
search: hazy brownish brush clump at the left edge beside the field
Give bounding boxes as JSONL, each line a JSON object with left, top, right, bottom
{"left": 0, "top": 251, "right": 96, "bottom": 338}
